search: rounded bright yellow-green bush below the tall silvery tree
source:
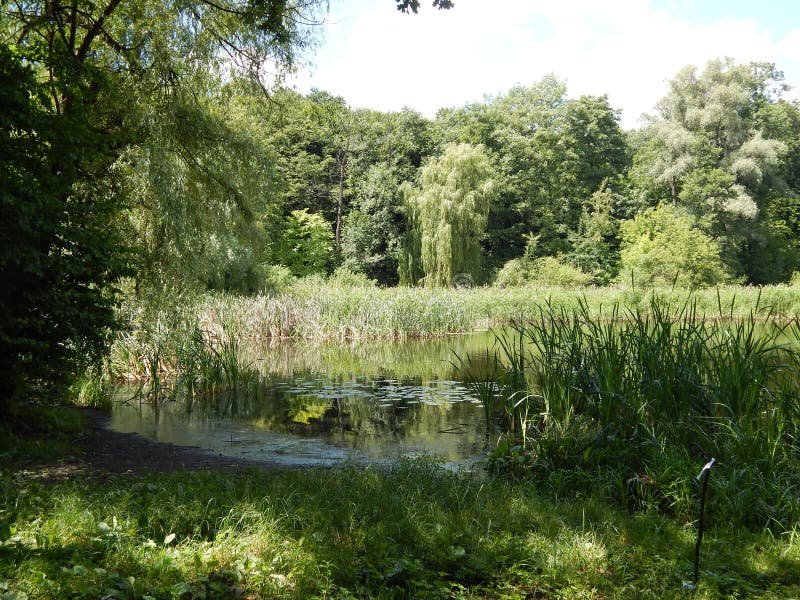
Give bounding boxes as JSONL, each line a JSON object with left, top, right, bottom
{"left": 619, "top": 204, "right": 730, "bottom": 289}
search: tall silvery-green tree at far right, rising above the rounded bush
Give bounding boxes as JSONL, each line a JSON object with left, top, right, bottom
{"left": 631, "top": 59, "right": 798, "bottom": 283}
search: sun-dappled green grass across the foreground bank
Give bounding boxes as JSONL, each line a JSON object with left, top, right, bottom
{"left": 0, "top": 462, "right": 800, "bottom": 598}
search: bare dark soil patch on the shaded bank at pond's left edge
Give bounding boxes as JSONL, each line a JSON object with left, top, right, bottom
{"left": 15, "top": 408, "right": 286, "bottom": 479}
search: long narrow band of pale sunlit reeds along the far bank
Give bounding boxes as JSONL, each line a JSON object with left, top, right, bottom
{"left": 119, "top": 280, "right": 800, "bottom": 340}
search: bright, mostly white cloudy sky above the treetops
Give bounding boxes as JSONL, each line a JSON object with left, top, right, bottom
{"left": 289, "top": 0, "right": 800, "bottom": 129}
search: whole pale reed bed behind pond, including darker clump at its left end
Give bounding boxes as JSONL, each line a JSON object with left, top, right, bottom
{"left": 108, "top": 280, "right": 800, "bottom": 389}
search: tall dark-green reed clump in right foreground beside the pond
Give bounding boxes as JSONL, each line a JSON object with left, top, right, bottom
{"left": 472, "top": 298, "right": 800, "bottom": 531}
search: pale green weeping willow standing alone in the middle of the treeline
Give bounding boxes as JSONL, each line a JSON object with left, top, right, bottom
{"left": 399, "top": 144, "right": 495, "bottom": 286}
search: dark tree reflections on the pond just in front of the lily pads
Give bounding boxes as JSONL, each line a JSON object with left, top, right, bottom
{"left": 115, "top": 378, "right": 485, "bottom": 460}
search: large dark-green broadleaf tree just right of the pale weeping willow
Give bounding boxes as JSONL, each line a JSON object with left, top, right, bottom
{"left": 437, "top": 75, "right": 629, "bottom": 267}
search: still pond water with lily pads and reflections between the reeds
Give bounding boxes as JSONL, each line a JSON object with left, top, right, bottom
{"left": 111, "top": 332, "right": 494, "bottom": 468}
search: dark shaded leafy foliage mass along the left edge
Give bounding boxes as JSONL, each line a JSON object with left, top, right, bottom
{"left": 0, "top": 45, "right": 129, "bottom": 412}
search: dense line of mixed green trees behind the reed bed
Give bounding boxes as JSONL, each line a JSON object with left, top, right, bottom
{"left": 130, "top": 60, "right": 800, "bottom": 292}
